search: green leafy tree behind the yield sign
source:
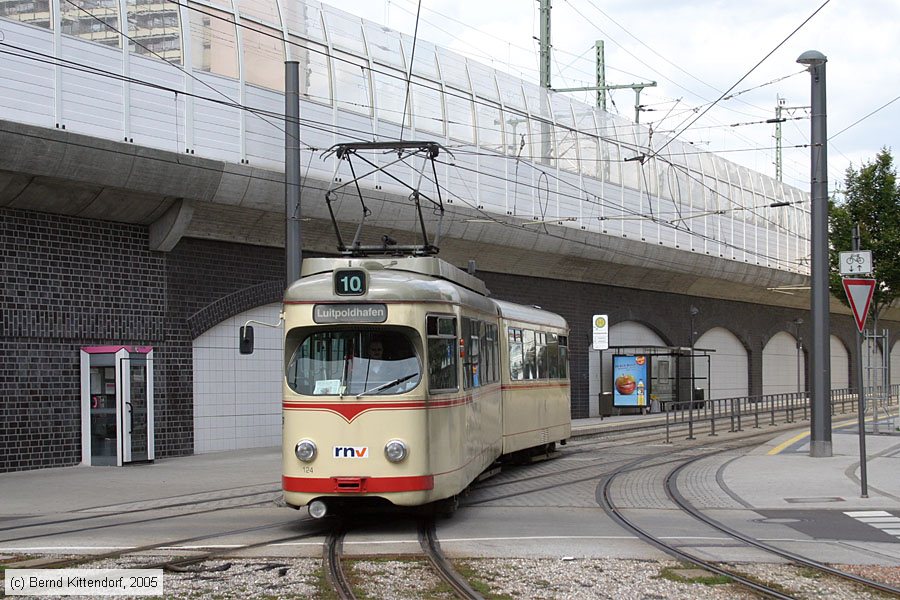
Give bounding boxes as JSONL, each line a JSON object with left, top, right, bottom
{"left": 829, "top": 148, "right": 900, "bottom": 319}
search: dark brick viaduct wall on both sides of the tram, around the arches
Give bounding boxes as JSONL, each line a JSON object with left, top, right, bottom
{"left": 0, "top": 209, "right": 900, "bottom": 472}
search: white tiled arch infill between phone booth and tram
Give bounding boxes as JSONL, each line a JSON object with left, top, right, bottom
{"left": 194, "top": 303, "right": 284, "bottom": 454}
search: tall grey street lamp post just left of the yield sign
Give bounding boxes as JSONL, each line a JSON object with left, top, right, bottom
{"left": 797, "top": 50, "right": 832, "bottom": 457}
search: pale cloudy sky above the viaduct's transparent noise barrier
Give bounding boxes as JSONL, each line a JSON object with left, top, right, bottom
{"left": 324, "top": 0, "right": 900, "bottom": 193}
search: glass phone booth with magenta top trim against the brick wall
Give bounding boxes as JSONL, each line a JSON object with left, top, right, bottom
{"left": 81, "top": 346, "right": 154, "bottom": 466}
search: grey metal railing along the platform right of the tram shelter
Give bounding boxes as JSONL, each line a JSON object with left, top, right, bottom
{"left": 660, "top": 384, "right": 900, "bottom": 443}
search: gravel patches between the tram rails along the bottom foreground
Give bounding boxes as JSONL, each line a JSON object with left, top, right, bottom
{"left": 33, "top": 557, "right": 900, "bottom": 600}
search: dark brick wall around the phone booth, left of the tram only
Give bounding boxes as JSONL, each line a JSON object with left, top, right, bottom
{"left": 0, "top": 210, "right": 284, "bottom": 472}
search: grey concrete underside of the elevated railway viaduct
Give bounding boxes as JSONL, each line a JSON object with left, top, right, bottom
{"left": 0, "top": 122, "right": 849, "bottom": 314}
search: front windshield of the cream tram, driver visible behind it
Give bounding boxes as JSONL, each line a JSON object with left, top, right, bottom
{"left": 287, "top": 329, "right": 422, "bottom": 396}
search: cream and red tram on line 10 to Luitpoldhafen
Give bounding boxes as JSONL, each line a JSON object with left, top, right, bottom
{"left": 283, "top": 257, "right": 570, "bottom": 516}
